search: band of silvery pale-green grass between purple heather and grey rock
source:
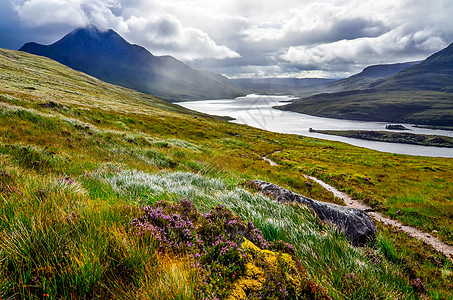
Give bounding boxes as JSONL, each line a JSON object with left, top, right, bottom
{"left": 96, "top": 170, "right": 417, "bottom": 299}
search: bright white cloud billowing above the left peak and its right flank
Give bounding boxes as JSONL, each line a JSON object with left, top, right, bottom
{"left": 14, "top": 0, "right": 240, "bottom": 61}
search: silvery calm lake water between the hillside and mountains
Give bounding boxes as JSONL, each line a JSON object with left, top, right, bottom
{"left": 178, "top": 95, "right": 453, "bottom": 157}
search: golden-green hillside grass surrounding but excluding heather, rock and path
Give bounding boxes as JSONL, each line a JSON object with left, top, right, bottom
{"left": 0, "top": 50, "right": 453, "bottom": 299}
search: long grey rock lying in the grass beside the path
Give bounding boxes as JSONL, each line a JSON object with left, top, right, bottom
{"left": 248, "top": 180, "right": 377, "bottom": 246}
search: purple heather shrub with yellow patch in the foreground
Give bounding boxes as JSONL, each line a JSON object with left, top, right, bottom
{"left": 132, "top": 199, "right": 329, "bottom": 299}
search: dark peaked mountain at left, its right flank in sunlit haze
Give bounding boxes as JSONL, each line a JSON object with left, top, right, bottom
{"left": 19, "top": 28, "right": 245, "bottom": 101}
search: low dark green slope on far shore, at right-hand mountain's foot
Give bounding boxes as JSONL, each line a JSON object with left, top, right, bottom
{"left": 283, "top": 89, "right": 453, "bottom": 126}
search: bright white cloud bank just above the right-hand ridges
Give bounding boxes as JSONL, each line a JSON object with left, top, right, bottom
{"left": 281, "top": 27, "right": 447, "bottom": 71}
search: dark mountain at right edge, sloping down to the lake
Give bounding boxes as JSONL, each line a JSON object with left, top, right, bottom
{"left": 279, "top": 44, "right": 453, "bottom": 127}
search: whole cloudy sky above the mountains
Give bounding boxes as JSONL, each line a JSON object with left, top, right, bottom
{"left": 0, "top": 0, "right": 453, "bottom": 78}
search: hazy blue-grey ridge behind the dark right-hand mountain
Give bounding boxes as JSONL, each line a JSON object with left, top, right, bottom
{"left": 328, "top": 61, "right": 420, "bottom": 90}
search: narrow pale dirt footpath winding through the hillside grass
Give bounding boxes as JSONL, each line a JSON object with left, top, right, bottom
{"left": 262, "top": 151, "right": 453, "bottom": 262}
